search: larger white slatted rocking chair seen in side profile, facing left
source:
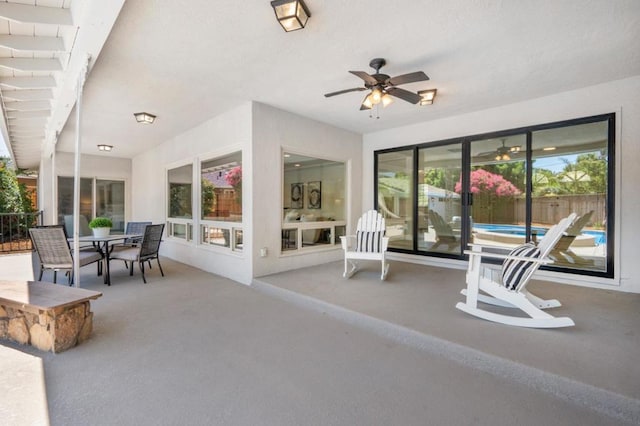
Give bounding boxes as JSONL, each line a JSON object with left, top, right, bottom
{"left": 456, "top": 213, "right": 576, "bottom": 328}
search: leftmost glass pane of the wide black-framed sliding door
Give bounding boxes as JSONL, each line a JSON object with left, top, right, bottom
{"left": 377, "top": 149, "right": 414, "bottom": 250}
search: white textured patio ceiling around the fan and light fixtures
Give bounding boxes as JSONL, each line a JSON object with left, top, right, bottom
{"left": 2, "top": 0, "right": 640, "bottom": 169}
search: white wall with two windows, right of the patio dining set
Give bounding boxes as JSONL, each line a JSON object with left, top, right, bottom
{"left": 132, "top": 103, "right": 253, "bottom": 284}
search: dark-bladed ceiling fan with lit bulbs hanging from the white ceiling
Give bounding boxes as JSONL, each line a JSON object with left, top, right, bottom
{"left": 324, "top": 58, "right": 429, "bottom": 110}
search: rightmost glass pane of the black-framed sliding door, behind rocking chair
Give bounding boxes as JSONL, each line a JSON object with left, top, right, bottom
{"left": 531, "top": 121, "right": 610, "bottom": 271}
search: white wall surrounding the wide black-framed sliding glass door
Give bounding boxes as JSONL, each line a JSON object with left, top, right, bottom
{"left": 362, "top": 76, "right": 640, "bottom": 293}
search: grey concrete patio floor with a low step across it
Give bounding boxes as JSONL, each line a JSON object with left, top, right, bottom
{"left": 0, "top": 255, "right": 640, "bottom": 425}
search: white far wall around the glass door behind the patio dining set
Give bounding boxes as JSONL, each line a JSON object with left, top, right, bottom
{"left": 38, "top": 152, "right": 131, "bottom": 225}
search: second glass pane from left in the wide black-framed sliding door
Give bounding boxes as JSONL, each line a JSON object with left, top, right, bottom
{"left": 418, "top": 143, "right": 466, "bottom": 254}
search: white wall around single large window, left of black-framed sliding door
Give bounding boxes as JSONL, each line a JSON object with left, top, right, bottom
{"left": 252, "top": 103, "right": 362, "bottom": 276}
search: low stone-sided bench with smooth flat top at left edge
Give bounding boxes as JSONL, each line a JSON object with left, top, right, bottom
{"left": 0, "top": 280, "right": 102, "bottom": 353}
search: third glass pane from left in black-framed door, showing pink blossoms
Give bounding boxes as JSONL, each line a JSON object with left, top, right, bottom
{"left": 469, "top": 134, "right": 529, "bottom": 248}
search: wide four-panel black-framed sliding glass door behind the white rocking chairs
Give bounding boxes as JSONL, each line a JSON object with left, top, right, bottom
{"left": 375, "top": 114, "right": 615, "bottom": 277}
